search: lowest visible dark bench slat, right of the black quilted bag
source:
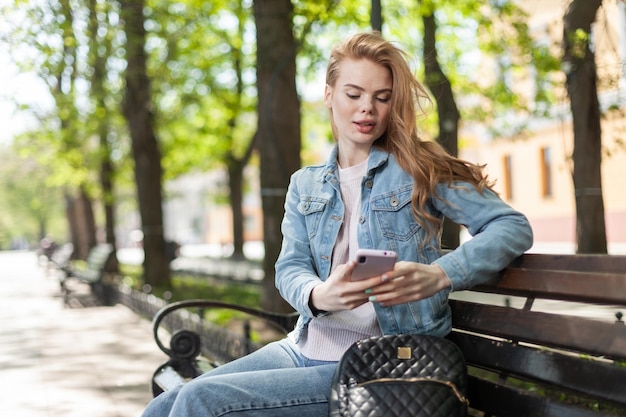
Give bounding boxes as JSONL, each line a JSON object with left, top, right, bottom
{"left": 469, "top": 376, "right": 606, "bottom": 417}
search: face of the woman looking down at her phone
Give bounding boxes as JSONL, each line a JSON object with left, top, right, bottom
{"left": 324, "top": 58, "right": 392, "bottom": 157}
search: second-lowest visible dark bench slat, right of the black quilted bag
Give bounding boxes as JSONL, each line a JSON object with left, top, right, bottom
{"left": 450, "top": 332, "right": 626, "bottom": 406}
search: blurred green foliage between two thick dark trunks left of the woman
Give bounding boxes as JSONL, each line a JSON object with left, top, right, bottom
{"left": 146, "top": 0, "right": 256, "bottom": 178}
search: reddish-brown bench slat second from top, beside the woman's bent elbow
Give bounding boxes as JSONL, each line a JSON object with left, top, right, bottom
{"left": 474, "top": 268, "right": 626, "bottom": 305}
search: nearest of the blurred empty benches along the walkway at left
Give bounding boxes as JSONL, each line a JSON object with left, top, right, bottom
{"left": 60, "top": 243, "right": 115, "bottom": 306}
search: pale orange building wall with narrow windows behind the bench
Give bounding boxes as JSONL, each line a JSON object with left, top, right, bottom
{"left": 461, "top": 111, "right": 626, "bottom": 250}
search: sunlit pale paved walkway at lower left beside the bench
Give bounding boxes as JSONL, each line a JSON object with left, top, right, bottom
{"left": 0, "top": 252, "right": 165, "bottom": 417}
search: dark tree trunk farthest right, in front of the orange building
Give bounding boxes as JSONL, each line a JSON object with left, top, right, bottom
{"left": 562, "top": 0, "right": 607, "bottom": 253}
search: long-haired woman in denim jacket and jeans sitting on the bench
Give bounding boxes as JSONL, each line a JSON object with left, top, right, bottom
{"left": 144, "top": 33, "right": 532, "bottom": 417}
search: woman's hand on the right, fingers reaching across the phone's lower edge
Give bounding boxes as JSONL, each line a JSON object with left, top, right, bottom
{"left": 368, "top": 262, "right": 452, "bottom": 306}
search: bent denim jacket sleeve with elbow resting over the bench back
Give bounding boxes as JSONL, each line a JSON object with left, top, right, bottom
{"left": 433, "top": 183, "right": 533, "bottom": 291}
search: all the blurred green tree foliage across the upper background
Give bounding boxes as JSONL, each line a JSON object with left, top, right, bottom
{"left": 2, "top": 0, "right": 564, "bottom": 247}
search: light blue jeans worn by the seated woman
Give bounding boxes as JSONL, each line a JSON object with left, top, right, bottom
{"left": 142, "top": 339, "right": 337, "bottom": 417}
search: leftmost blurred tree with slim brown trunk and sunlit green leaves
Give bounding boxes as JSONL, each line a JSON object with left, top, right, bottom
{"left": 8, "top": 0, "right": 96, "bottom": 259}
